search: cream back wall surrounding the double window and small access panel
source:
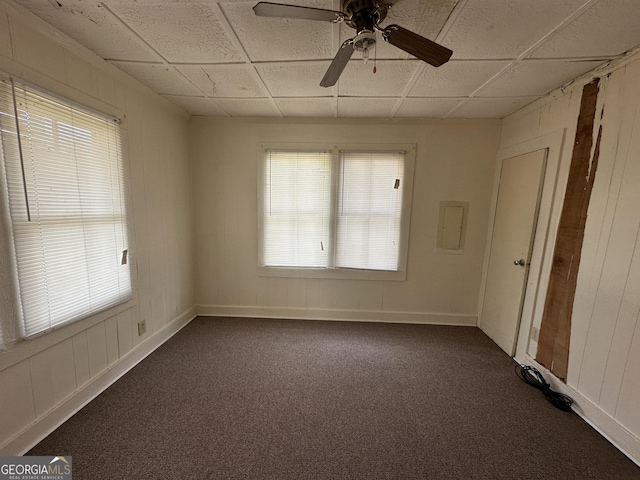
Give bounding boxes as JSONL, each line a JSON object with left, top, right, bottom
{"left": 190, "top": 117, "right": 501, "bottom": 325}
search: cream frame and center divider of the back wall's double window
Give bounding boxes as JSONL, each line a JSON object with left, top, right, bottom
{"left": 257, "top": 142, "right": 416, "bottom": 281}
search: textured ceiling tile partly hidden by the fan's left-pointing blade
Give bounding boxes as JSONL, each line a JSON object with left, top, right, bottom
{"left": 220, "top": 0, "right": 338, "bottom": 61}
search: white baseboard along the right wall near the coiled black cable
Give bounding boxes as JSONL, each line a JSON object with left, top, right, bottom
{"left": 515, "top": 355, "right": 640, "bottom": 467}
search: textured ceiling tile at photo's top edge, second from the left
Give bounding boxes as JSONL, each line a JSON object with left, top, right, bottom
{"left": 107, "top": 0, "right": 243, "bottom": 63}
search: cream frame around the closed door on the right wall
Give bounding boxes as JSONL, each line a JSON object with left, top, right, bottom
{"left": 477, "top": 129, "right": 565, "bottom": 363}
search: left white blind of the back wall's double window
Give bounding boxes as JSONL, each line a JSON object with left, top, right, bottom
{"left": 263, "top": 150, "right": 331, "bottom": 267}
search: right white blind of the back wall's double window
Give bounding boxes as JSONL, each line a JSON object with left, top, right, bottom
{"left": 335, "top": 151, "right": 404, "bottom": 271}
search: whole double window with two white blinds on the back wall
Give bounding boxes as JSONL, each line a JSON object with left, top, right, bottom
{"left": 260, "top": 146, "right": 414, "bottom": 279}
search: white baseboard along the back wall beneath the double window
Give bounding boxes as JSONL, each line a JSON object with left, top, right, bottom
{"left": 197, "top": 305, "right": 478, "bottom": 327}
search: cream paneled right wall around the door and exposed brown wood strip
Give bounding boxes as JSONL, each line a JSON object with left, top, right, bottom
{"left": 501, "top": 52, "right": 640, "bottom": 463}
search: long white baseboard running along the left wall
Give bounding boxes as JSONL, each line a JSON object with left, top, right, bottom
{"left": 0, "top": 306, "right": 196, "bottom": 455}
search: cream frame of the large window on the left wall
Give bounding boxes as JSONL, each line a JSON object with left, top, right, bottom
{"left": 0, "top": 72, "right": 138, "bottom": 351}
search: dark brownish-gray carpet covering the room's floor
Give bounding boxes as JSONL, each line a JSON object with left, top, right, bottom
{"left": 29, "top": 318, "right": 640, "bottom": 480}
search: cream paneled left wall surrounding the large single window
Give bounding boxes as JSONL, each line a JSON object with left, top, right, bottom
{"left": 0, "top": 0, "right": 195, "bottom": 455}
